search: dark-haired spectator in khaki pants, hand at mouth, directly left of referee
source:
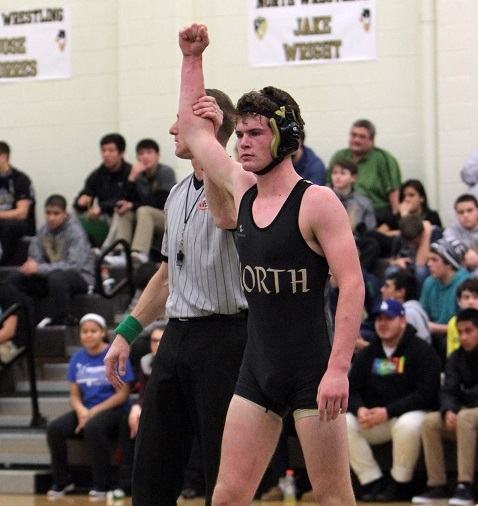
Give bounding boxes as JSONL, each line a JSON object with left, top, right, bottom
{"left": 105, "top": 139, "right": 176, "bottom": 265}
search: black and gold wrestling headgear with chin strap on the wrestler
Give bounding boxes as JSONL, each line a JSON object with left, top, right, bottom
{"left": 254, "top": 106, "right": 300, "bottom": 176}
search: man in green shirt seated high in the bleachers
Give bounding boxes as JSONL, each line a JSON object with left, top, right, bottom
{"left": 329, "top": 119, "right": 401, "bottom": 225}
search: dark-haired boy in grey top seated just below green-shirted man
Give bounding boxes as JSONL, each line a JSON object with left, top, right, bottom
{"left": 330, "top": 158, "right": 380, "bottom": 272}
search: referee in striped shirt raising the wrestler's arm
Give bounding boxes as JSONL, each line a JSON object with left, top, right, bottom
{"left": 105, "top": 90, "right": 247, "bottom": 506}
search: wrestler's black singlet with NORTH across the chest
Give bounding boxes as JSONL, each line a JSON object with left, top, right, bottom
{"left": 236, "top": 180, "right": 331, "bottom": 416}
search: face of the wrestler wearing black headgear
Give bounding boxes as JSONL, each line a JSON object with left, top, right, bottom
{"left": 236, "top": 114, "right": 272, "bottom": 172}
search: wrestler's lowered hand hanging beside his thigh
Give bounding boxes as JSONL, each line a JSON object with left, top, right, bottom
{"left": 317, "top": 369, "right": 349, "bottom": 422}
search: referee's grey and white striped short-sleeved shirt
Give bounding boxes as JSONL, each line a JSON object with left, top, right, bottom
{"left": 161, "top": 175, "right": 247, "bottom": 318}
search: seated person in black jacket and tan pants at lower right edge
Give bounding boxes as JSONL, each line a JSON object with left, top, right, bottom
{"left": 413, "top": 308, "right": 478, "bottom": 505}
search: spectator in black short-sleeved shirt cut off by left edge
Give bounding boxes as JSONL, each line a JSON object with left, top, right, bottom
{"left": 0, "top": 141, "right": 35, "bottom": 265}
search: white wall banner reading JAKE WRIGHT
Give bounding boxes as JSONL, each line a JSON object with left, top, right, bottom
{"left": 247, "top": 0, "right": 377, "bottom": 67}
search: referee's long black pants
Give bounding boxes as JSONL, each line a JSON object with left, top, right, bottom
{"left": 132, "top": 315, "right": 247, "bottom": 506}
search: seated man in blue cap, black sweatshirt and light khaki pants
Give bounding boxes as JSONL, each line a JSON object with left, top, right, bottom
{"left": 347, "top": 299, "right": 440, "bottom": 502}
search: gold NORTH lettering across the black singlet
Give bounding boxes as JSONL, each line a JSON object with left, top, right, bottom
{"left": 241, "top": 264, "right": 310, "bottom": 295}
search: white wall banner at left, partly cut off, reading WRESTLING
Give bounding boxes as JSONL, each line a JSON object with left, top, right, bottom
{"left": 0, "top": 7, "right": 71, "bottom": 83}
